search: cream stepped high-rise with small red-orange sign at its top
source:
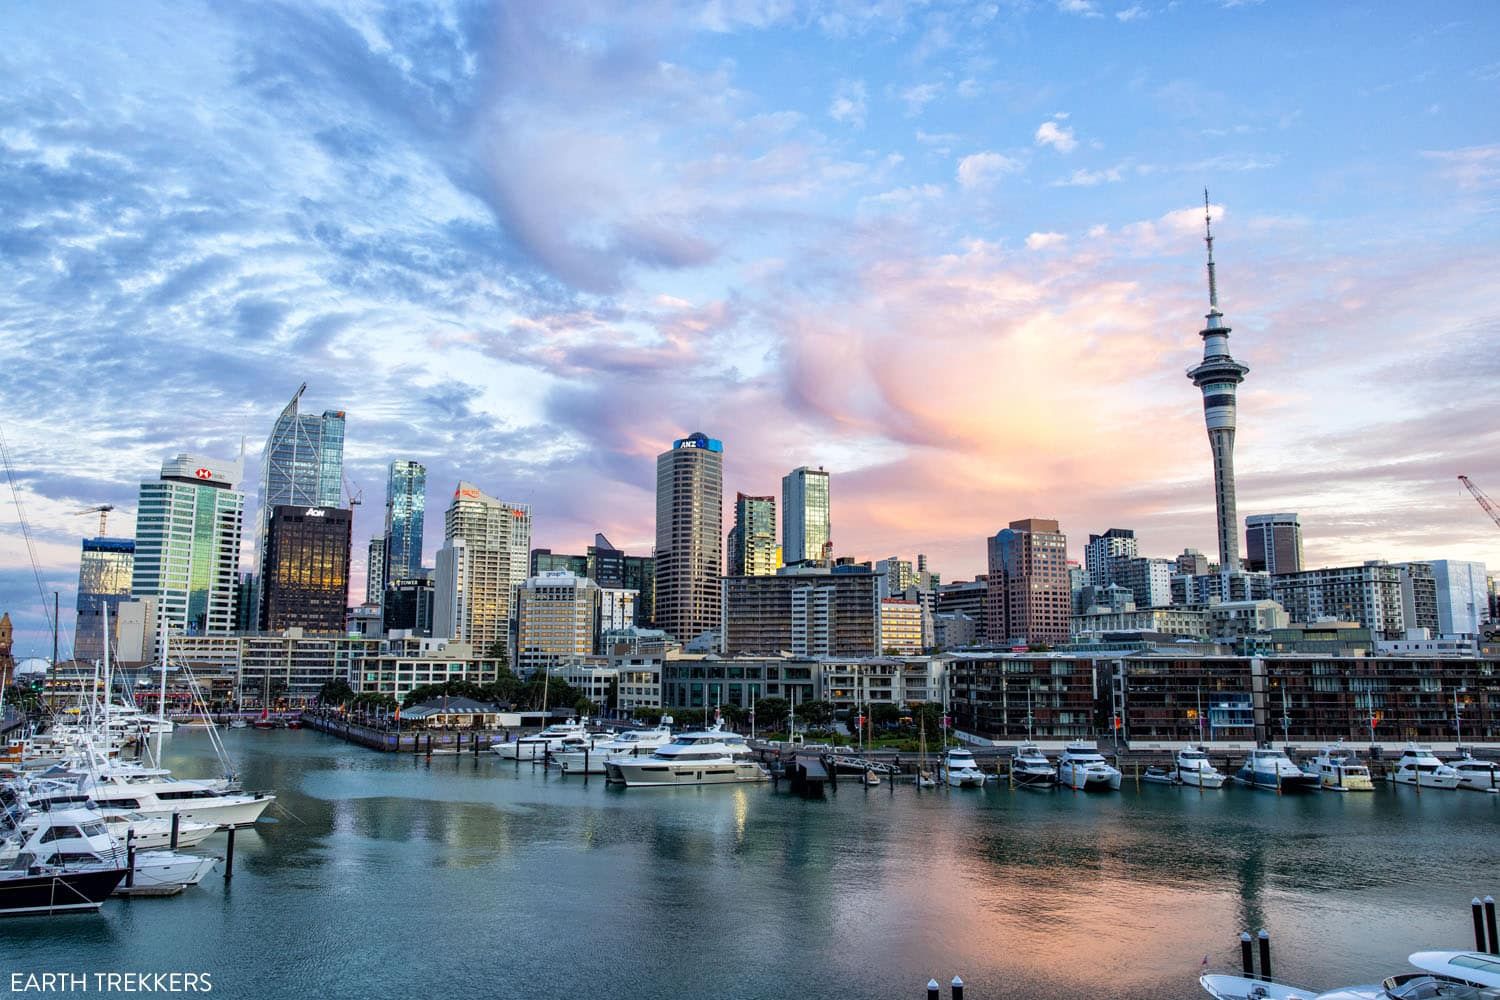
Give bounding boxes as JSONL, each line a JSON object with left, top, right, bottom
{"left": 432, "top": 483, "right": 531, "bottom": 654}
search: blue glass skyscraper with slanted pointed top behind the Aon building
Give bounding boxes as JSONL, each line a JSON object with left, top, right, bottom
{"left": 255, "top": 382, "right": 344, "bottom": 626}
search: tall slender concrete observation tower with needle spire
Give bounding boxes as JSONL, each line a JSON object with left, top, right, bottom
{"left": 1188, "top": 187, "right": 1250, "bottom": 573}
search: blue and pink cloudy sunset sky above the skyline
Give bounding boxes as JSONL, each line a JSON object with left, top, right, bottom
{"left": 0, "top": 0, "right": 1500, "bottom": 655}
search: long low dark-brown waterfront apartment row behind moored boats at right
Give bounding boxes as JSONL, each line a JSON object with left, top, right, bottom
{"left": 948, "top": 649, "right": 1500, "bottom": 747}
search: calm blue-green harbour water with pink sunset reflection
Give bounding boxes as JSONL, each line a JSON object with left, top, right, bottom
{"left": 0, "top": 730, "right": 1500, "bottom": 1000}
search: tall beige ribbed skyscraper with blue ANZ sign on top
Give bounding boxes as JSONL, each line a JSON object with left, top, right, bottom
{"left": 656, "top": 433, "right": 725, "bottom": 643}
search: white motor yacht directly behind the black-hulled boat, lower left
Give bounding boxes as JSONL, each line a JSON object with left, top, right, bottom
{"left": 0, "top": 808, "right": 219, "bottom": 886}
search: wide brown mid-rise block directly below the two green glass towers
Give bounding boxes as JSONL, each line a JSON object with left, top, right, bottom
{"left": 719, "top": 567, "right": 876, "bottom": 657}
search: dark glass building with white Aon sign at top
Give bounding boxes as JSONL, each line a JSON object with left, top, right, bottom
{"left": 260, "top": 504, "right": 354, "bottom": 636}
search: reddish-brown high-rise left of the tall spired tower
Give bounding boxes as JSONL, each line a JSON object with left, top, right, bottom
{"left": 986, "top": 517, "right": 1073, "bottom": 645}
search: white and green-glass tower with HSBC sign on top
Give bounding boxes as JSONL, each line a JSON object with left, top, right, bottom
{"left": 131, "top": 454, "right": 245, "bottom": 636}
